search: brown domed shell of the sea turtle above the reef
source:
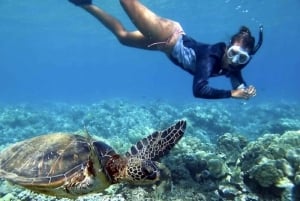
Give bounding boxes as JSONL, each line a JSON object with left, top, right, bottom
{"left": 0, "top": 133, "right": 115, "bottom": 197}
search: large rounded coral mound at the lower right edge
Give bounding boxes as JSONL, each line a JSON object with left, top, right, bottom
{"left": 240, "top": 131, "right": 300, "bottom": 197}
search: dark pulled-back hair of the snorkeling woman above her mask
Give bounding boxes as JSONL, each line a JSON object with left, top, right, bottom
{"left": 230, "top": 26, "right": 255, "bottom": 52}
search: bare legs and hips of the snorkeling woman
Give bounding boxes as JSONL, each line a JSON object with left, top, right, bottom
{"left": 77, "top": 0, "right": 182, "bottom": 54}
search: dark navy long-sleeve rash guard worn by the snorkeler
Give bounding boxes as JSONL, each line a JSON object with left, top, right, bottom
{"left": 170, "top": 35, "right": 246, "bottom": 99}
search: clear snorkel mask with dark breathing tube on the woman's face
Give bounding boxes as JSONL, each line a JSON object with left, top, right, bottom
{"left": 226, "top": 25, "right": 263, "bottom": 65}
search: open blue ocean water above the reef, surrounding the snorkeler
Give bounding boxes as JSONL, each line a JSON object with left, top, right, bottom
{"left": 0, "top": 0, "right": 300, "bottom": 103}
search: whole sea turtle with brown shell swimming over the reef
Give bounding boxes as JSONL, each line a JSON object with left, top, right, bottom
{"left": 0, "top": 120, "right": 186, "bottom": 198}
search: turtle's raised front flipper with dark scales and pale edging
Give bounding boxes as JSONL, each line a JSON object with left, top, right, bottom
{"left": 126, "top": 120, "right": 186, "bottom": 160}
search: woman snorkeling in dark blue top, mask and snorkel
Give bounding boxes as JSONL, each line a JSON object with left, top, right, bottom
{"left": 69, "top": 0, "right": 263, "bottom": 99}
